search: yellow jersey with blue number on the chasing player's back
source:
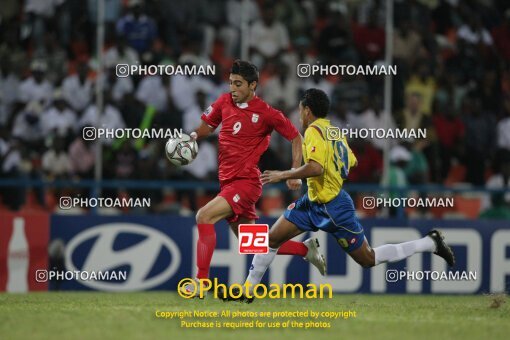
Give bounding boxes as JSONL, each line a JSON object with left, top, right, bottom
{"left": 303, "top": 118, "right": 357, "bottom": 203}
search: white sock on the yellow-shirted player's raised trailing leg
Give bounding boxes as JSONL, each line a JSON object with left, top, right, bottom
{"left": 374, "top": 236, "right": 436, "bottom": 266}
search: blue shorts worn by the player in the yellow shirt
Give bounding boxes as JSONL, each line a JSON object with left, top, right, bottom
{"left": 283, "top": 190, "right": 365, "bottom": 253}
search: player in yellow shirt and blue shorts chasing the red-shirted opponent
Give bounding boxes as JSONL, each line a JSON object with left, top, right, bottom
{"left": 226, "top": 89, "right": 455, "bottom": 302}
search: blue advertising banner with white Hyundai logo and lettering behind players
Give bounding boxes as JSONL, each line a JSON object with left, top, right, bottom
{"left": 50, "top": 215, "right": 510, "bottom": 294}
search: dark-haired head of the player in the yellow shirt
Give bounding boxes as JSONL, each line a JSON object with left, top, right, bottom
{"left": 299, "top": 89, "right": 329, "bottom": 129}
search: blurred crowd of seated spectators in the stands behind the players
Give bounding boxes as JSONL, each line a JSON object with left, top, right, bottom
{"left": 0, "top": 0, "right": 510, "bottom": 218}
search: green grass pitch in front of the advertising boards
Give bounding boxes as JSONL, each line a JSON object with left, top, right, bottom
{"left": 0, "top": 292, "right": 510, "bottom": 340}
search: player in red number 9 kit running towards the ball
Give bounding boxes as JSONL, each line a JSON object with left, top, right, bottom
{"left": 181, "top": 60, "right": 326, "bottom": 295}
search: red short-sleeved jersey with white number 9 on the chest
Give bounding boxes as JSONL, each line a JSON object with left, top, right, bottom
{"left": 202, "top": 93, "right": 299, "bottom": 183}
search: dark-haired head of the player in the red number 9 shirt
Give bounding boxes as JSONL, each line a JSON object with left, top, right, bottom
{"left": 229, "top": 59, "right": 259, "bottom": 103}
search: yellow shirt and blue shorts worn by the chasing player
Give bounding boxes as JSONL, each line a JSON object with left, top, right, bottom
{"left": 283, "top": 118, "right": 365, "bottom": 253}
